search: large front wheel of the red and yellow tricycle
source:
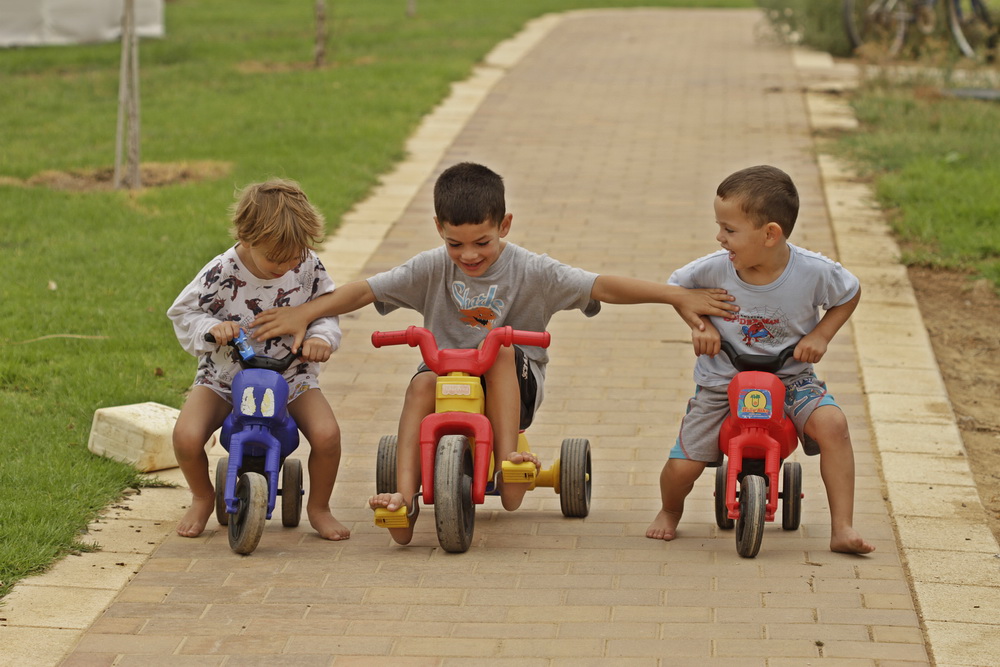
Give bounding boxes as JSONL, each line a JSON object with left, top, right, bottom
{"left": 434, "top": 435, "right": 476, "bottom": 553}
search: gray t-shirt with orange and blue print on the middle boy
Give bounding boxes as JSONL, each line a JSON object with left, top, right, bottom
{"left": 368, "top": 242, "right": 601, "bottom": 403}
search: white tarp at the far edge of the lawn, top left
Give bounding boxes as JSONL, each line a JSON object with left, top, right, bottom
{"left": 0, "top": 0, "right": 164, "bottom": 46}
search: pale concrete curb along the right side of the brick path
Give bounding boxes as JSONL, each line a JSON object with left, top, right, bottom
{"left": 794, "top": 50, "right": 1000, "bottom": 665}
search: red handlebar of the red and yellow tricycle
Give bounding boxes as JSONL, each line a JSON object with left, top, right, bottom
{"left": 372, "top": 327, "right": 551, "bottom": 376}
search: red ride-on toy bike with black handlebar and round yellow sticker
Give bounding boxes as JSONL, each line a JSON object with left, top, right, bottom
{"left": 715, "top": 341, "right": 802, "bottom": 558}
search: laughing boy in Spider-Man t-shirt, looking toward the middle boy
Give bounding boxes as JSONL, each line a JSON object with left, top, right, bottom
{"left": 646, "top": 166, "right": 875, "bottom": 554}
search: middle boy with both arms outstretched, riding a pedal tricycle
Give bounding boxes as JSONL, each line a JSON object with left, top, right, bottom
{"left": 253, "top": 162, "right": 738, "bottom": 544}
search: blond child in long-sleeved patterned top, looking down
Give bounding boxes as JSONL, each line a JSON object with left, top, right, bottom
{"left": 174, "top": 179, "right": 350, "bottom": 540}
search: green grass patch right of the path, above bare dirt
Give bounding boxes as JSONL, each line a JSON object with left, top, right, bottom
{"left": 837, "top": 82, "right": 1000, "bottom": 290}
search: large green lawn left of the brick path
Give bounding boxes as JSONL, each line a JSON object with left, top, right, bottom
{"left": 0, "top": 0, "right": 752, "bottom": 597}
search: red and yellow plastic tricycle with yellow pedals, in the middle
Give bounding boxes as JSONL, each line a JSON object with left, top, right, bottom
{"left": 372, "top": 327, "right": 591, "bottom": 553}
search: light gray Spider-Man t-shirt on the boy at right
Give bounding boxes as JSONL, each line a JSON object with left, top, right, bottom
{"left": 668, "top": 243, "right": 860, "bottom": 387}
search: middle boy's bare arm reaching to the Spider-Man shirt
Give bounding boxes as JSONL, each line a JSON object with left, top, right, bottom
{"left": 590, "top": 275, "right": 740, "bottom": 330}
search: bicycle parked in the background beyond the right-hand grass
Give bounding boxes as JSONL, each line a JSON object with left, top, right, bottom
{"left": 842, "top": 0, "right": 997, "bottom": 61}
